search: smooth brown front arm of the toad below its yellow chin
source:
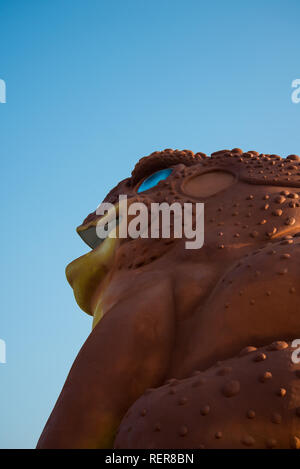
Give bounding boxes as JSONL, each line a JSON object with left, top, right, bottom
{"left": 37, "top": 278, "right": 174, "bottom": 448}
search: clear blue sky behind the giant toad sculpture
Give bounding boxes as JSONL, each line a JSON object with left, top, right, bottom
{"left": 0, "top": 0, "right": 300, "bottom": 448}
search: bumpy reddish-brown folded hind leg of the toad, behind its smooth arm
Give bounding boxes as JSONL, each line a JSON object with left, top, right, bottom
{"left": 115, "top": 342, "right": 300, "bottom": 449}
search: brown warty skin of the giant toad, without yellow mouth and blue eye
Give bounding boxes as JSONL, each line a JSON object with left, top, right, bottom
{"left": 38, "top": 149, "right": 300, "bottom": 448}
